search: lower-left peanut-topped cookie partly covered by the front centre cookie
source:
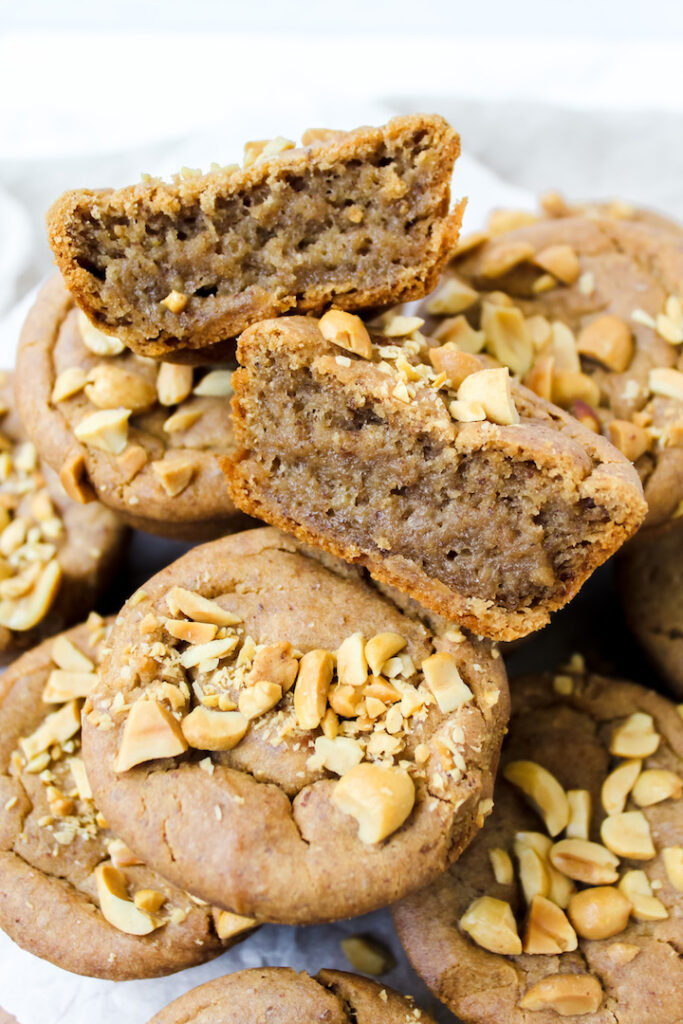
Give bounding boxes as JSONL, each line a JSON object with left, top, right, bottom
{"left": 0, "top": 613, "right": 255, "bottom": 981}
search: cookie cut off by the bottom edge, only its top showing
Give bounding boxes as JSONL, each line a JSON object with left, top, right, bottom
{"left": 150, "top": 967, "right": 434, "bottom": 1024}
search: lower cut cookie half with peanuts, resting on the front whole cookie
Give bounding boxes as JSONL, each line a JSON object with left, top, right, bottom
{"left": 225, "top": 311, "right": 646, "bottom": 640}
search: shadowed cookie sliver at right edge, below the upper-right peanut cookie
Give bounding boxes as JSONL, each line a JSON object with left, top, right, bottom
{"left": 616, "top": 528, "right": 683, "bottom": 699}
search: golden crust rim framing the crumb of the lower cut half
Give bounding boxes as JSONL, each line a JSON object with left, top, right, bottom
{"left": 223, "top": 317, "right": 645, "bottom": 640}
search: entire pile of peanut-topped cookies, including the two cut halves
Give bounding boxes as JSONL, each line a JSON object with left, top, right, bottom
{"left": 0, "top": 116, "right": 683, "bottom": 1024}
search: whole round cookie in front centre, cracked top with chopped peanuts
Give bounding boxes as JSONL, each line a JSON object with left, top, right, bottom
{"left": 84, "top": 528, "right": 508, "bottom": 924}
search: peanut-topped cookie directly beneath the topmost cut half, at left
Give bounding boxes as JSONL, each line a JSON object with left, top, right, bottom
{"left": 14, "top": 278, "right": 247, "bottom": 541}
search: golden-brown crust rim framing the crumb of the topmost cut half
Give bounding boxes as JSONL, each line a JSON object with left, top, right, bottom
{"left": 47, "top": 115, "right": 463, "bottom": 358}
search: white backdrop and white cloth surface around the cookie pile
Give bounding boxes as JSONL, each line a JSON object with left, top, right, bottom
{"left": 0, "top": 0, "right": 683, "bottom": 1024}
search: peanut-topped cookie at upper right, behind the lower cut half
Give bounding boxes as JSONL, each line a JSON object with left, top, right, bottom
{"left": 424, "top": 217, "right": 683, "bottom": 527}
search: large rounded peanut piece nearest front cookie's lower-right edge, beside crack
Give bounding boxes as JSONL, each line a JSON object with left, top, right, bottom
{"left": 332, "top": 762, "right": 415, "bottom": 844}
